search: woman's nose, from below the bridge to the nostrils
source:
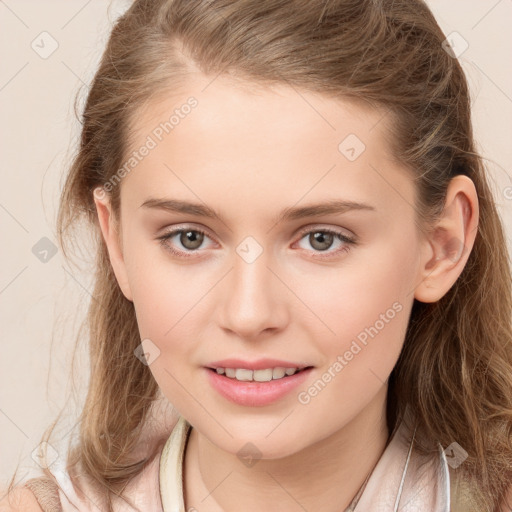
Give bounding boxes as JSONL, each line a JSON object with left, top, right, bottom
{"left": 216, "top": 247, "right": 289, "bottom": 340}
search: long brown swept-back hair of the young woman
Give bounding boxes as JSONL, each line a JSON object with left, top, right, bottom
{"left": 5, "top": 0, "right": 512, "bottom": 512}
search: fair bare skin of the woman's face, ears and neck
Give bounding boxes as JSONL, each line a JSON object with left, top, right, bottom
{"left": 95, "top": 75, "right": 478, "bottom": 512}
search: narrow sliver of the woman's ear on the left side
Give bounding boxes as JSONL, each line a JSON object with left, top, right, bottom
{"left": 94, "top": 187, "right": 133, "bottom": 302}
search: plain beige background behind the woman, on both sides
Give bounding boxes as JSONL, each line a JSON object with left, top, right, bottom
{"left": 0, "top": 0, "right": 512, "bottom": 488}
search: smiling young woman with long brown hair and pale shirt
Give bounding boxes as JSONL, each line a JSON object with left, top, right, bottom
{"left": 4, "top": 0, "right": 512, "bottom": 512}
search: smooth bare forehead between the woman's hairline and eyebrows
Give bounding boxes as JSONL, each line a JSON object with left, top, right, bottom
{"left": 122, "top": 75, "right": 414, "bottom": 222}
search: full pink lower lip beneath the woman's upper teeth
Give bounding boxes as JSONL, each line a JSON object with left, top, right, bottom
{"left": 206, "top": 368, "right": 313, "bottom": 407}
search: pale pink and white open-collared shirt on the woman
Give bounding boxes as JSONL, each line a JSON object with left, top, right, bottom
{"left": 38, "top": 406, "right": 450, "bottom": 512}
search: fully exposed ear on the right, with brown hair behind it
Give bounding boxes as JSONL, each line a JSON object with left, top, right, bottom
{"left": 414, "top": 175, "right": 479, "bottom": 302}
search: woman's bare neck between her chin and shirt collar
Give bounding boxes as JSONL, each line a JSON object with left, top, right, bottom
{"left": 184, "top": 385, "right": 389, "bottom": 512}
